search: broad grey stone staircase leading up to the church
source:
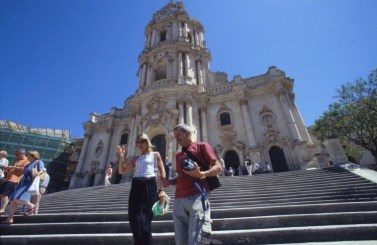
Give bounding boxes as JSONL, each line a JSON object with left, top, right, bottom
{"left": 0, "top": 169, "right": 377, "bottom": 245}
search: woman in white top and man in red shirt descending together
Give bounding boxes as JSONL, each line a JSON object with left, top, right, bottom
{"left": 118, "top": 124, "right": 223, "bottom": 245}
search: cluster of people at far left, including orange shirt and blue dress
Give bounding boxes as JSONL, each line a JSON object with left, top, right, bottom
{"left": 0, "top": 148, "right": 50, "bottom": 224}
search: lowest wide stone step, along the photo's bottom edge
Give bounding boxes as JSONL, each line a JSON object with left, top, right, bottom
{"left": 0, "top": 224, "right": 377, "bottom": 245}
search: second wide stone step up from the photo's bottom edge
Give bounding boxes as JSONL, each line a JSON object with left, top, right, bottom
{"left": 2, "top": 211, "right": 377, "bottom": 235}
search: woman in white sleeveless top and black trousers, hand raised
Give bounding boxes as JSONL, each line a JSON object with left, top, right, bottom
{"left": 118, "top": 134, "right": 166, "bottom": 245}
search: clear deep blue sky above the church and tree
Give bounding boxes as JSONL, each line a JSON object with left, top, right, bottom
{"left": 0, "top": 0, "right": 377, "bottom": 138}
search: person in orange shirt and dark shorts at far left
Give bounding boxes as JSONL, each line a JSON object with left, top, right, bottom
{"left": 0, "top": 148, "right": 29, "bottom": 214}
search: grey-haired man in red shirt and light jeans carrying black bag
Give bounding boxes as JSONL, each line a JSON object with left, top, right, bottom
{"left": 168, "top": 124, "right": 223, "bottom": 244}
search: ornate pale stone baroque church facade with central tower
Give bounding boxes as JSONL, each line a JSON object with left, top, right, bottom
{"left": 70, "top": 2, "right": 318, "bottom": 188}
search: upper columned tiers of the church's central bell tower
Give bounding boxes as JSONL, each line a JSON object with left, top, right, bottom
{"left": 138, "top": 2, "right": 211, "bottom": 94}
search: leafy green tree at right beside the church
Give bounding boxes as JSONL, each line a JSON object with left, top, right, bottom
{"left": 313, "top": 69, "right": 377, "bottom": 165}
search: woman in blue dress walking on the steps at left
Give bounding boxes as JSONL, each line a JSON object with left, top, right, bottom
{"left": 3, "top": 151, "right": 44, "bottom": 224}
